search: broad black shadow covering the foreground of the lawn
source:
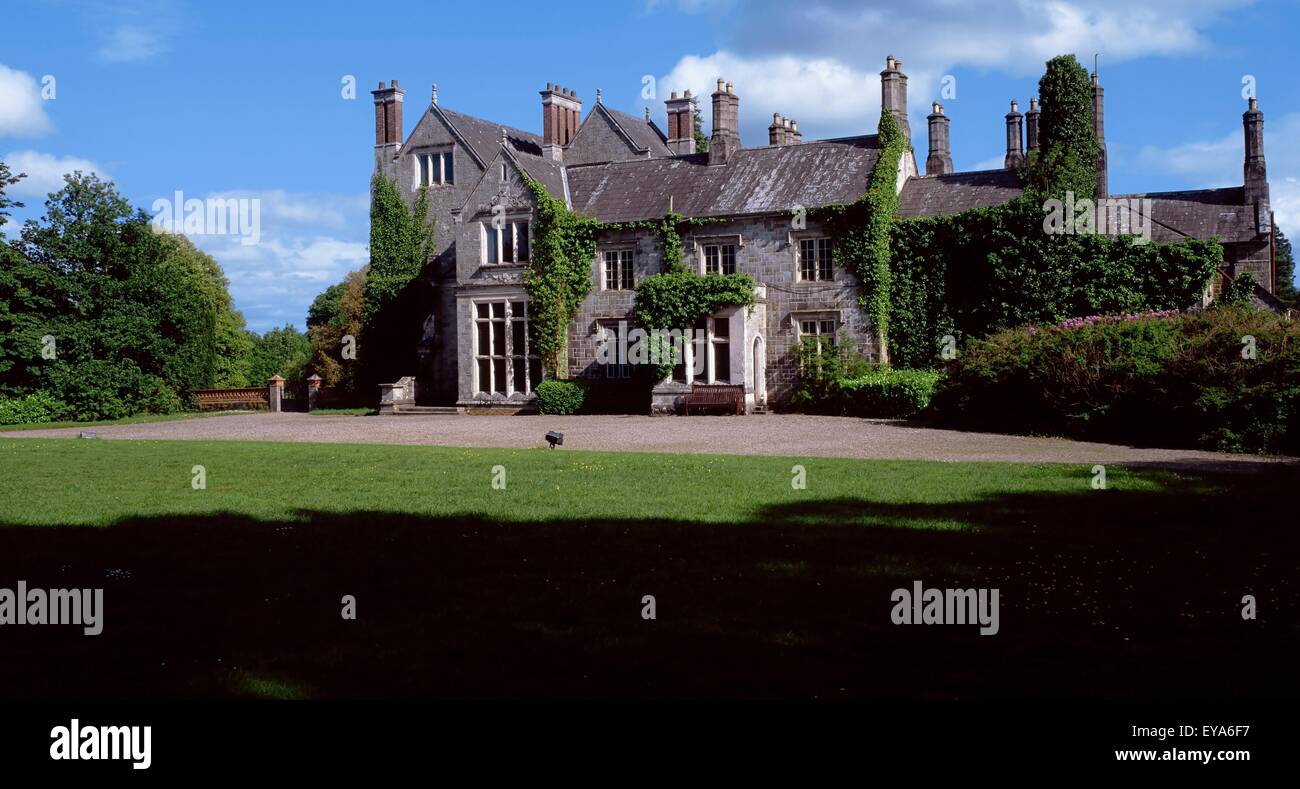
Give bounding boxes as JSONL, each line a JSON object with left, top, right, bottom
{"left": 0, "top": 474, "right": 1300, "bottom": 697}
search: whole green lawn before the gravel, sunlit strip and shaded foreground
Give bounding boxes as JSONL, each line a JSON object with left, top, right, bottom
{"left": 0, "top": 439, "right": 1300, "bottom": 698}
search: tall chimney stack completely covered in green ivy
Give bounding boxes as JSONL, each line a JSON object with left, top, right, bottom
{"left": 1024, "top": 55, "right": 1099, "bottom": 200}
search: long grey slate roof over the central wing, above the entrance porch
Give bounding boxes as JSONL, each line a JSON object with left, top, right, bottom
{"left": 568, "top": 135, "right": 880, "bottom": 222}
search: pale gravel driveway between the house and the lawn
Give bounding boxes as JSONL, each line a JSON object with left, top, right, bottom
{"left": 0, "top": 413, "right": 1295, "bottom": 468}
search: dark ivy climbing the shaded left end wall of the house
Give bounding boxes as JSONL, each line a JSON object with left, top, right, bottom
{"left": 358, "top": 175, "right": 434, "bottom": 396}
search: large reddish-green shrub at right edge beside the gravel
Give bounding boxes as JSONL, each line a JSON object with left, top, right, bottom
{"left": 933, "top": 307, "right": 1300, "bottom": 454}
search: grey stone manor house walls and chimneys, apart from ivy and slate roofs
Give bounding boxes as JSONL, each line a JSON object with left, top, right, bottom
{"left": 372, "top": 56, "right": 1275, "bottom": 411}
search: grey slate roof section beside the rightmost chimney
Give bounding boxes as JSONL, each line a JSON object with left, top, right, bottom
{"left": 1114, "top": 186, "right": 1258, "bottom": 243}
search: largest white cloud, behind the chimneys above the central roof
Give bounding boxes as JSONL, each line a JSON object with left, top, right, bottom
{"left": 657, "top": 0, "right": 1252, "bottom": 138}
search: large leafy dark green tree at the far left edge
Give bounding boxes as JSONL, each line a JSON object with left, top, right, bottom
{"left": 0, "top": 173, "right": 230, "bottom": 419}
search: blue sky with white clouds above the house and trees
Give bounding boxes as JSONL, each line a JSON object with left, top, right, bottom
{"left": 0, "top": 0, "right": 1300, "bottom": 330}
